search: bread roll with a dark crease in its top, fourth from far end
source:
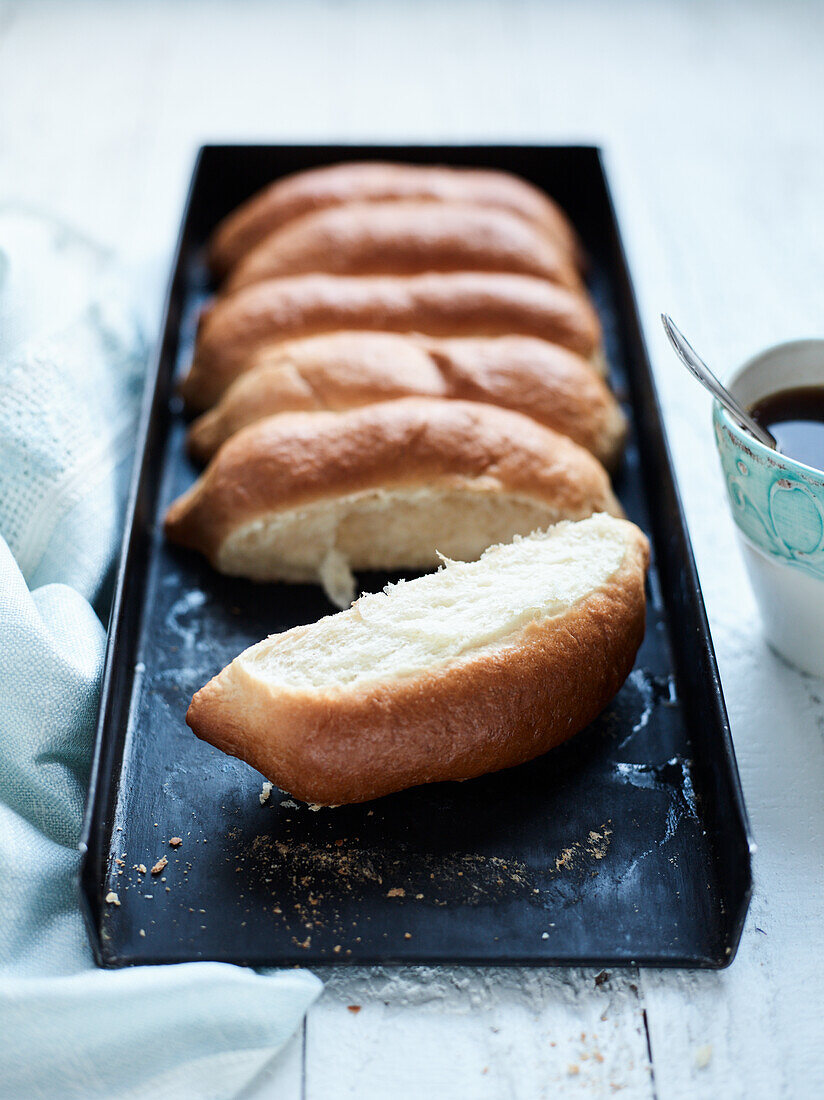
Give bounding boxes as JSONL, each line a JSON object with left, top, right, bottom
{"left": 189, "top": 332, "right": 626, "bottom": 468}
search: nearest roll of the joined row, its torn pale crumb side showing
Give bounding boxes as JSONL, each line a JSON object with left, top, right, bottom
{"left": 166, "top": 397, "right": 620, "bottom": 606}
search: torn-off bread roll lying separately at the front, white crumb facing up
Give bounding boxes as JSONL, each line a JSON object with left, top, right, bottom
{"left": 186, "top": 515, "right": 648, "bottom": 805}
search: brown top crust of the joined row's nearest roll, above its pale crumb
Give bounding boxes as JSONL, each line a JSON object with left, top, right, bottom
{"left": 165, "top": 397, "right": 620, "bottom": 563}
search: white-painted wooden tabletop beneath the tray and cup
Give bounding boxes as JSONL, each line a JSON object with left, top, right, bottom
{"left": 0, "top": 0, "right": 824, "bottom": 1100}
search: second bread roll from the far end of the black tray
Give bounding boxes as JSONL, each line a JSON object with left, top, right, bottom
{"left": 224, "top": 202, "right": 582, "bottom": 293}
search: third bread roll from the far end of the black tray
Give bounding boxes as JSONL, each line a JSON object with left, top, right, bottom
{"left": 180, "top": 272, "right": 601, "bottom": 409}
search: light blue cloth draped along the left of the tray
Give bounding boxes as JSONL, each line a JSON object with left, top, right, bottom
{"left": 0, "top": 207, "right": 320, "bottom": 1100}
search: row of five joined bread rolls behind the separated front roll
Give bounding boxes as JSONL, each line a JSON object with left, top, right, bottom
{"left": 166, "top": 163, "right": 626, "bottom": 606}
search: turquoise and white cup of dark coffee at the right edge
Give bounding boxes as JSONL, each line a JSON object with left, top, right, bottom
{"left": 713, "top": 340, "right": 824, "bottom": 677}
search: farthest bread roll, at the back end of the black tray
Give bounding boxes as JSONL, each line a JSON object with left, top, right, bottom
{"left": 209, "top": 161, "right": 579, "bottom": 277}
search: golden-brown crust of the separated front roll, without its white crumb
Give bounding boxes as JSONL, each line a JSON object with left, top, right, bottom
{"left": 186, "top": 524, "right": 648, "bottom": 805}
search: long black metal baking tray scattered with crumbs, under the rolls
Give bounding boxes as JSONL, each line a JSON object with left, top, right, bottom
{"left": 81, "top": 145, "right": 752, "bottom": 967}
